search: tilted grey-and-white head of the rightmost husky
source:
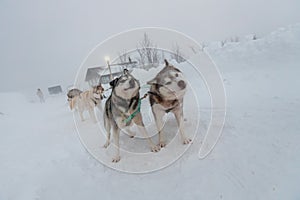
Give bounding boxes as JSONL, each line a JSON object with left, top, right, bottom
{"left": 147, "top": 60, "right": 187, "bottom": 99}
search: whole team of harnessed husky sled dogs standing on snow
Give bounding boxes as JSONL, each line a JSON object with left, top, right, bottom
{"left": 67, "top": 60, "right": 191, "bottom": 162}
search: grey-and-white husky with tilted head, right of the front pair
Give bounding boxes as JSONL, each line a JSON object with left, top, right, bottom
{"left": 147, "top": 60, "right": 191, "bottom": 147}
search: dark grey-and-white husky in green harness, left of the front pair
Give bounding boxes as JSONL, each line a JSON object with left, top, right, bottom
{"left": 103, "top": 70, "right": 160, "bottom": 162}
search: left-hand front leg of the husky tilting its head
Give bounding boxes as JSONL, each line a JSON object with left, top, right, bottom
{"left": 152, "top": 105, "right": 166, "bottom": 148}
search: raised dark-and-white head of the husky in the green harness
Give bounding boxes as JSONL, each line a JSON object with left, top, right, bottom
{"left": 109, "top": 70, "right": 140, "bottom": 99}
